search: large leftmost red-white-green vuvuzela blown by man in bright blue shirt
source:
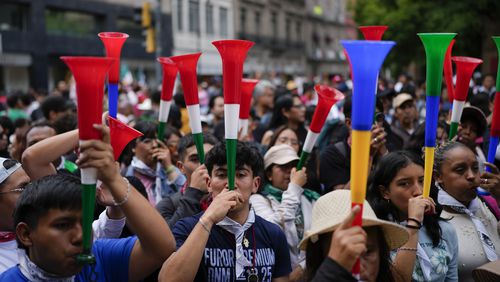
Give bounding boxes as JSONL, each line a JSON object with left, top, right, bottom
{"left": 61, "top": 57, "right": 116, "bottom": 264}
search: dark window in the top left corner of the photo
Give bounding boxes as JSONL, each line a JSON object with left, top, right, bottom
{"left": 0, "top": 3, "right": 29, "bottom": 31}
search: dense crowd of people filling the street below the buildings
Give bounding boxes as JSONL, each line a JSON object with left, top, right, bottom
{"left": 0, "top": 69, "right": 500, "bottom": 282}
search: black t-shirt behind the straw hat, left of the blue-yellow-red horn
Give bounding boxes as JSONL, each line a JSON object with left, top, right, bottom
{"left": 319, "top": 141, "right": 351, "bottom": 193}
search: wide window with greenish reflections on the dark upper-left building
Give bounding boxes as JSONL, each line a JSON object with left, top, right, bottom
{"left": 45, "top": 8, "right": 103, "bottom": 37}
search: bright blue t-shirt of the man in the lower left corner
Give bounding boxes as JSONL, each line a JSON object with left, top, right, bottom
{"left": 0, "top": 236, "right": 137, "bottom": 282}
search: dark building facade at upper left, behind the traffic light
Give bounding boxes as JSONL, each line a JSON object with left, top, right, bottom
{"left": 0, "top": 0, "right": 173, "bottom": 92}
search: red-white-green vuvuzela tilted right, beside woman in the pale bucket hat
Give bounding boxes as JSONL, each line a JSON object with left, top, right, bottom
{"left": 297, "top": 84, "right": 344, "bottom": 170}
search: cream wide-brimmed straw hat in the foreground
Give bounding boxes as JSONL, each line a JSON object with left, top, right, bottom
{"left": 299, "top": 190, "right": 409, "bottom": 250}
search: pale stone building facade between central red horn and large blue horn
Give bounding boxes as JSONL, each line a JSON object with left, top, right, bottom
{"left": 234, "top": 0, "right": 356, "bottom": 76}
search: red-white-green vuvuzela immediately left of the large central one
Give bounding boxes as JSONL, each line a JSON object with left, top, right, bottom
{"left": 170, "top": 53, "right": 205, "bottom": 164}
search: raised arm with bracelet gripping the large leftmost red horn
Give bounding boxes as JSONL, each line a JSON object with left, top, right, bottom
{"left": 77, "top": 125, "right": 175, "bottom": 281}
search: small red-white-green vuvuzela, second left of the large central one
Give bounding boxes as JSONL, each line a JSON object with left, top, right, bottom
{"left": 157, "top": 57, "right": 177, "bottom": 140}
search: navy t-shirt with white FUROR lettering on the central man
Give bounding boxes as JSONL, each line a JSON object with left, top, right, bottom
{"left": 173, "top": 213, "right": 292, "bottom": 282}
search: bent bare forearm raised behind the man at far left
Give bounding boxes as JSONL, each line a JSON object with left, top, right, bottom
{"left": 22, "top": 129, "right": 78, "bottom": 181}
